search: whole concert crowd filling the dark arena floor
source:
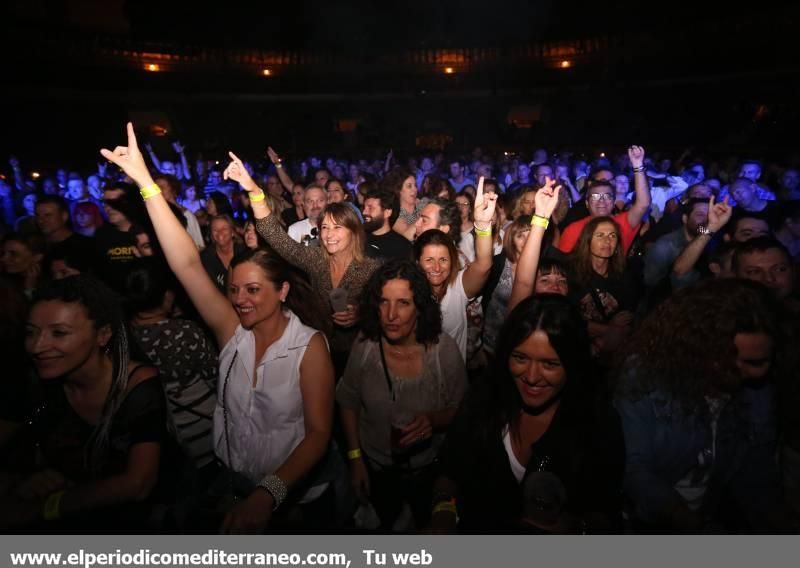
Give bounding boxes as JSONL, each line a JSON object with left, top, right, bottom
{"left": 0, "top": 124, "right": 800, "bottom": 534}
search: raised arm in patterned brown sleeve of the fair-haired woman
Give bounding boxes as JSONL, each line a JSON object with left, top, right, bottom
{"left": 222, "top": 152, "right": 320, "bottom": 274}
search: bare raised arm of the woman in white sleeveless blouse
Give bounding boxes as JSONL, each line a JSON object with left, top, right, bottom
{"left": 100, "top": 122, "right": 239, "bottom": 347}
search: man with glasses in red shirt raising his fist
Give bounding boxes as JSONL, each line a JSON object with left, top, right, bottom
{"left": 558, "top": 146, "right": 650, "bottom": 255}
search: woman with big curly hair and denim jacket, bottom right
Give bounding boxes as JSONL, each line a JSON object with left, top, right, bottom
{"left": 616, "top": 279, "right": 781, "bottom": 533}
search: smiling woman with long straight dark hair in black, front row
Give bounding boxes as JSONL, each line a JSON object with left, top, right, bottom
{"left": 432, "top": 295, "right": 623, "bottom": 533}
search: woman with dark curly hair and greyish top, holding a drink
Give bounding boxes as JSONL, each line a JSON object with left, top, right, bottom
{"left": 336, "top": 260, "right": 467, "bottom": 529}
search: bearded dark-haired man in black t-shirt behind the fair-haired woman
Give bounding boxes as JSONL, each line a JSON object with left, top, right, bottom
{"left": 364, "top": 190, "right": 411, "bottom": 260}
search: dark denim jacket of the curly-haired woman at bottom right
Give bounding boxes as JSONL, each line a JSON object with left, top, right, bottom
{"left": 616, "top": 384, "right": 780, "bottom": 531}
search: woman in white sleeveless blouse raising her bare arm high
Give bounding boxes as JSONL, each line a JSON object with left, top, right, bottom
{"left": 101, "top": 123, "right": 334, "bottom": 533}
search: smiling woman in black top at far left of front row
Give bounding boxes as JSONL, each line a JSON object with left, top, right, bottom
{"left": 0, "top": 276, "right": 179, "bottom": 533}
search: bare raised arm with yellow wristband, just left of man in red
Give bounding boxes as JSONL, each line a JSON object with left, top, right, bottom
{"left": 508, "top": 178, "right": 561, "bottom": 313}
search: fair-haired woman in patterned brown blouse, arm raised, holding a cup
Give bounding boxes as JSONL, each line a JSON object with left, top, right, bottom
{"left": 224, "top": 152, "right": 379, "bottom": 377}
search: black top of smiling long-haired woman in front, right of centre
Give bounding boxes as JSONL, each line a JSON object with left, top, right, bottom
{"left": 439, "top": 383, "right": 625, "bottom": 533}
